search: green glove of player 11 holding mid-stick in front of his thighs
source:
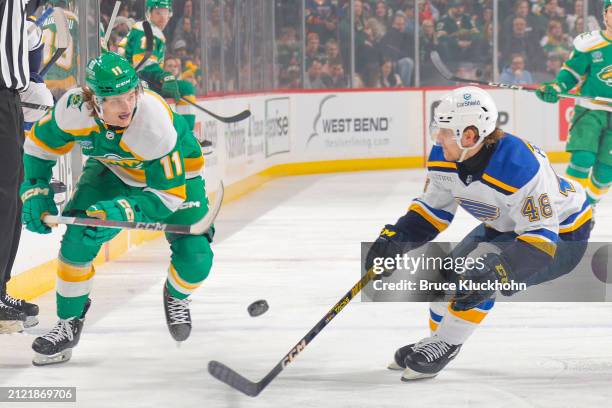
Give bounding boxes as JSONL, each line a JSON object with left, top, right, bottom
{"left": 83, "top": 197, "right": 145, "bottom": 245}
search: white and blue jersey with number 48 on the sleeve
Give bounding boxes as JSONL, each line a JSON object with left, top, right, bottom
{"left": 410, "top": 134, "right": 592, "bottom": 257}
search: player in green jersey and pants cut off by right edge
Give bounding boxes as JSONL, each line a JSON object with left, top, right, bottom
{"left": 536, "top": 0, "right": 612, "bottom": 204}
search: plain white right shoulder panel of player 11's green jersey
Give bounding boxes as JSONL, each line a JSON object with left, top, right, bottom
{"left": 121, "top": 90, "right": 178, "bottom": 160}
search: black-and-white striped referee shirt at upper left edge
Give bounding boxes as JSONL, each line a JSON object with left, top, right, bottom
{"left": 0, "top": 0, "right": 30, "bottom": 90}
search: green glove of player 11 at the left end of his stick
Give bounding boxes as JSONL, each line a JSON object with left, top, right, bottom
{"left": 19, "top": 180, "right": 58, "bottom": 234}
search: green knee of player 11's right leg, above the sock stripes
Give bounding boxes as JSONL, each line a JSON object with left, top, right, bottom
{"left": 171, "top": 236, "right": 213, "bottom": 283}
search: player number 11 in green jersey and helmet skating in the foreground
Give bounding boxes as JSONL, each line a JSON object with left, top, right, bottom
{"left": 21, "top": 53, "right": 213, "bottom": 365}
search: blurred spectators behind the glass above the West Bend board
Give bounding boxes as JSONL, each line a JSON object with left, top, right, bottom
{"left": 277, "top": 0, "right": 603, "bottom": 88}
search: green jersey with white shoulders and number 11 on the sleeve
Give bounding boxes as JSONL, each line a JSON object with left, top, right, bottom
{"left": 24, "top": 88, "right": 204, "bottom": 221}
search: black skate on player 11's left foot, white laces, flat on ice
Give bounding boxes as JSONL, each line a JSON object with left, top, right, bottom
{"left": 32, "top": 299, "right": 91, "bottom": 366}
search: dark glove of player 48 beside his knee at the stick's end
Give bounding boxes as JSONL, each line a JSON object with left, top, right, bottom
{"left": 451, "top": 253, "right": 511, "bottom": 311}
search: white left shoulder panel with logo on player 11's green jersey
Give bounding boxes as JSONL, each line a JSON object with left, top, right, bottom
{"left": 54, "top": 88, "right": 99, "bottom": 136}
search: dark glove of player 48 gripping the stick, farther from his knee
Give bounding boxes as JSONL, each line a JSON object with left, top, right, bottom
{"left": 365, "top": 224, "right": 409, "bottom": 277}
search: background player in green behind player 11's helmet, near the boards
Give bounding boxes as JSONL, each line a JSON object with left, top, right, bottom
{"left": 119, "top": 0, "right": 196, "bottom": 129}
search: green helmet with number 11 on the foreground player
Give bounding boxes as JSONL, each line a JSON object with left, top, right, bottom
{"left": 85, "top": 52, "right": 140, "bottom": 98}
